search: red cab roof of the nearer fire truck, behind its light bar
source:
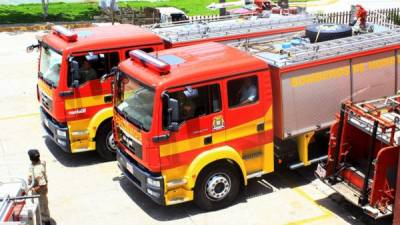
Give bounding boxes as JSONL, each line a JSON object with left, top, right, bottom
{"left": 120, "top": 42, "right": 268, "bottom": 89}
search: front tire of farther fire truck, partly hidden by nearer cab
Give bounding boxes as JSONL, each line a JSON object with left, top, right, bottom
{"left": 96, "top": 122, "right": 116, "bottom": 161}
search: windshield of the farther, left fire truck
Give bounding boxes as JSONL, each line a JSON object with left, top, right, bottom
{"left": 39, "top": 47, "right": 62, "bottom": 87}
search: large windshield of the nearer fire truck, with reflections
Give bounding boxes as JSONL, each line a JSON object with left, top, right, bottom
{"left": 116, "top": 72, "right": 154, "bottom": 131}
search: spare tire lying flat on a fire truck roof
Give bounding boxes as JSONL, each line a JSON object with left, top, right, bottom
{"left": 306, "top": 24, "right": 353, "bottom": 43}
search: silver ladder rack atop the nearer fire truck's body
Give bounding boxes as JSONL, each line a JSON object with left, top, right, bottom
{"left": 253, "top": 28, "right": 400, "bottom": 67}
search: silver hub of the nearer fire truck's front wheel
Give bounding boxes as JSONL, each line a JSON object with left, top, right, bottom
{"left": 206, "top": 173, "right": 231, "bottom": 201}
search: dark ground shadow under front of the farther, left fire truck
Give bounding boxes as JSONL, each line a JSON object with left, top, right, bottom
{"left": 43, "top": 136, "right": 107, "bottom": 167}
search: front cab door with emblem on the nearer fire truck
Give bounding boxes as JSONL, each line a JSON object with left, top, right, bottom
{"left": 160, "top": 82, "right": 225, "bottom": 167}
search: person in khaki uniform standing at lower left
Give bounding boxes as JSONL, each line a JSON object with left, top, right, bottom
{"left": 28, "top": 149, "right": 51, "bottom": 225}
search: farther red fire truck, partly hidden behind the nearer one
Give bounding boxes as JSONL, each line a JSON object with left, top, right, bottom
{"left": 29, "top": 15, "right": 313, "bottom": 159}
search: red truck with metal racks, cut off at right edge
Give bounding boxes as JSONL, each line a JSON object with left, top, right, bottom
{"left": 316, "top": 95, "right": 400, "bottom": 218}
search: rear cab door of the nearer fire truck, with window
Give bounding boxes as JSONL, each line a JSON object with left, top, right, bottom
{"left": 224, "top": 74, "right": 272, "bottom": 152}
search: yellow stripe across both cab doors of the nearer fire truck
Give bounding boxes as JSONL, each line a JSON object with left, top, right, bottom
{"left": 160, "top": 106, "right": 272, "bottom": 157}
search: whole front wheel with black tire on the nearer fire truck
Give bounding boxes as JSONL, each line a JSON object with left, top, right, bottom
{"left": 194, "top": 165, "right": 240, "bottom": 210}
